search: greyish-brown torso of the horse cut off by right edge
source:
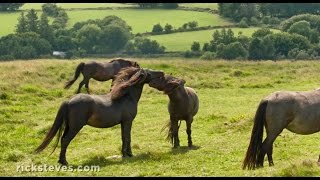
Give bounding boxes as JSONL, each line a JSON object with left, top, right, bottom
{"left": 264, "top": 90, "right": 320, "bottom": 134}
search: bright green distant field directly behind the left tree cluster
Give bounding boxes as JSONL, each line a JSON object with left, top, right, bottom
{"left": 0, "top": 8, "right": 232, "bottom": 36}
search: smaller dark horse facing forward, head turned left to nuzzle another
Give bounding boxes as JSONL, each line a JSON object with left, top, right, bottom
{"left": 149, "top": 75, "right": 199, "bottom": 148}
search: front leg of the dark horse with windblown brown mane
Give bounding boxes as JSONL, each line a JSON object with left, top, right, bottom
{"left": 121, "top": 120, "right": 133, "bottom": 157}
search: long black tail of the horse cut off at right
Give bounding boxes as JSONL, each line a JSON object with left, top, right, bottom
{"left": 242, "top": 100, "right": 268, "bottom": 169}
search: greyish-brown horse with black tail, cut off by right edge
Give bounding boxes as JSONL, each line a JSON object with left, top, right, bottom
{"left": 242, "top": 89, "right": 320, "bottom": 169}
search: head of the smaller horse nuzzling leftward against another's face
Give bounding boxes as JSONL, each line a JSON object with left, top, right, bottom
{"left": 149, "top": 75, "right": 186, "bottom": 94}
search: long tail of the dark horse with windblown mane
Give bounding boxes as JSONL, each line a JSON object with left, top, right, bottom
{"left": 34, "top": 101, "right": 68, "bottom": 154}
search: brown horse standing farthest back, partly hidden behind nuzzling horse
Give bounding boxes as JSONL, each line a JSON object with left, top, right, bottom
{"left": 64, "top": 58, "right": 140, "bottom": 94}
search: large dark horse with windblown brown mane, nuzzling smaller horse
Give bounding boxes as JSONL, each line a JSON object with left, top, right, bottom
{"left": 35, "top": 67, "right": 164, "bottom": 165}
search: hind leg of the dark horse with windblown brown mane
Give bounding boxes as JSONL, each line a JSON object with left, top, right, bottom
{"left": 58, "top": 120, "right": 83, "bottom": 165}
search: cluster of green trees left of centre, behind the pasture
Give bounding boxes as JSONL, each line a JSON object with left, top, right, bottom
{"left": 0, "top": 3, "right": 165, "bottom": 60}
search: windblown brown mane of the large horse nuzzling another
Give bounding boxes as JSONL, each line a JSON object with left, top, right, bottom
{"left": 110, "top": 67, "right": 146, "bottom": 100}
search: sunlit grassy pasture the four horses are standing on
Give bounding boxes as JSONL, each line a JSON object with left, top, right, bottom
{"left": 0, "top": 58, "right": 320, "bottom": 176}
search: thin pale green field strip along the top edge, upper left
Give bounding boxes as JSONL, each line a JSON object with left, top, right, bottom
{"left": 20, "top": 3, "right": 136, "bottom": 10}
